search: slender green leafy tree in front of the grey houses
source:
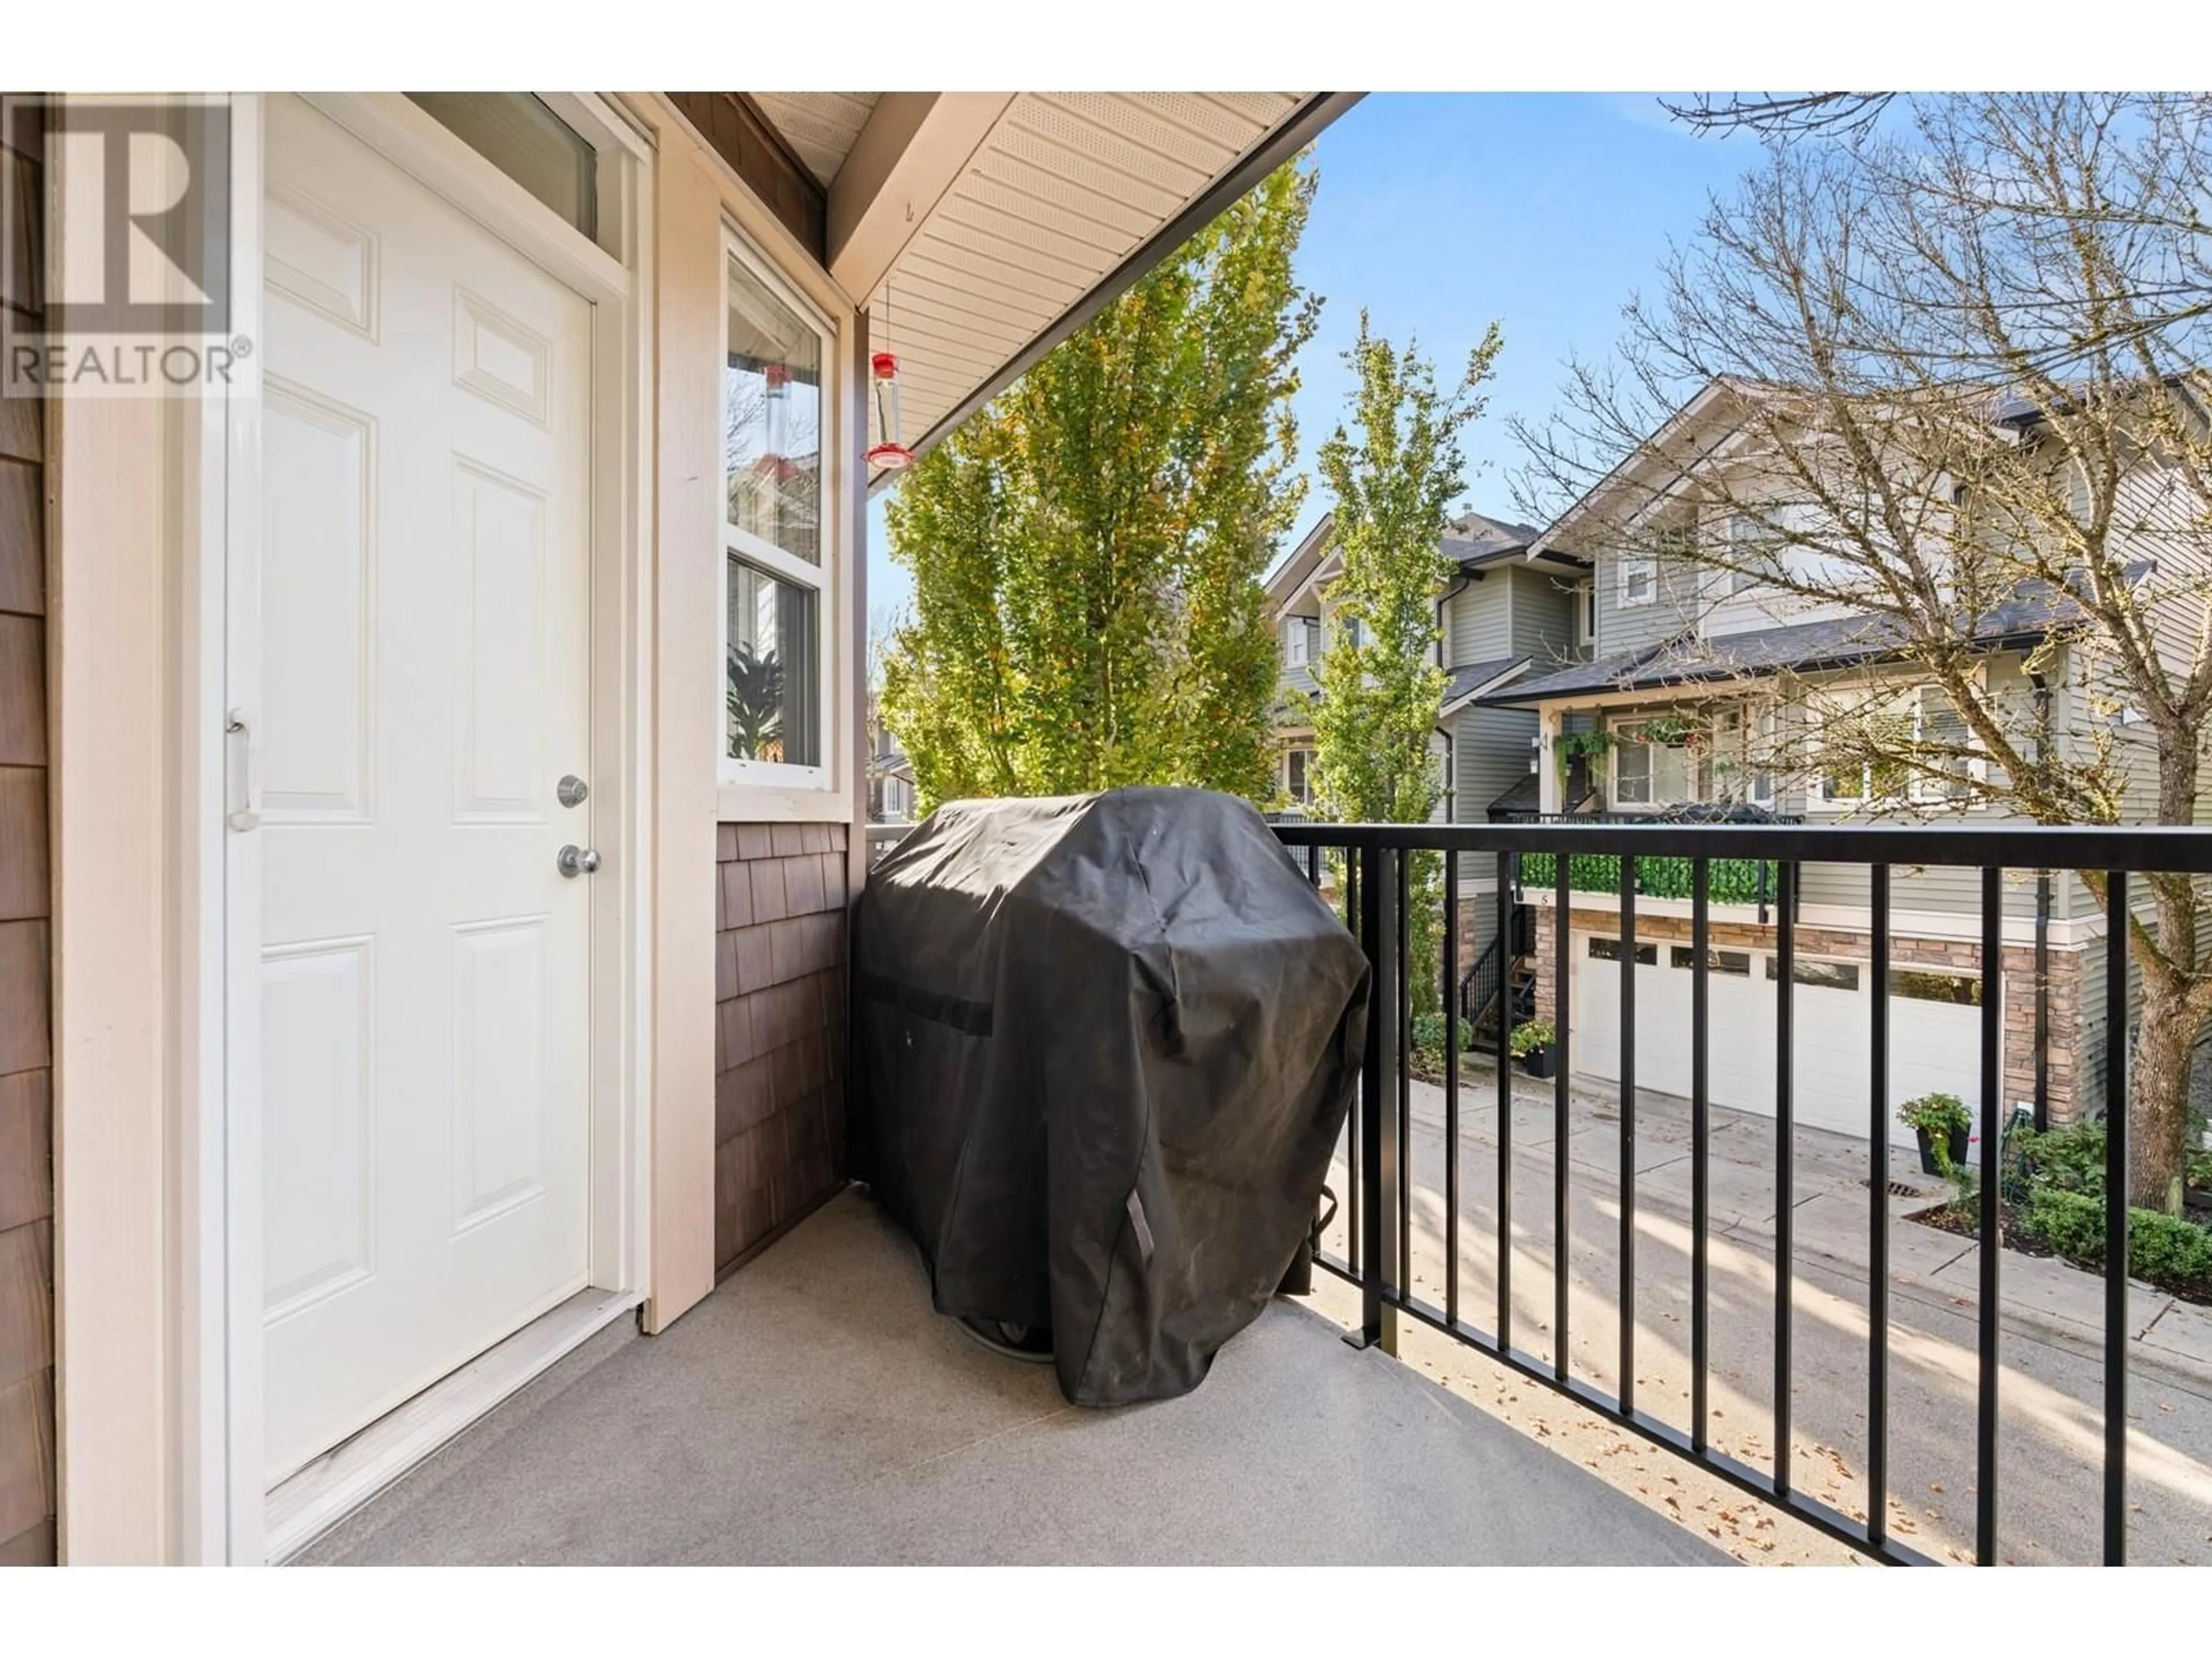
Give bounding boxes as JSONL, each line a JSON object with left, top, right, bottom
{"left": 1312, "top": 312, "right": 1504, "bottom": 1009}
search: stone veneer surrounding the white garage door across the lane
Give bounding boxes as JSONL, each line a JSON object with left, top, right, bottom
{"left": 1535, "top": 905, "right": 2086, "bottom": 1124}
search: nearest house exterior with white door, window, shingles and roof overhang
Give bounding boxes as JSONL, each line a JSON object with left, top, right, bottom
{"left": 0, "top": 84, "right": 1356, "bottom": 1564}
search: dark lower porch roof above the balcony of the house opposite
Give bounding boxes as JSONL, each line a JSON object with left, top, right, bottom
{"left": 1478, "top": 562, "right": 2150, "bottom": 703}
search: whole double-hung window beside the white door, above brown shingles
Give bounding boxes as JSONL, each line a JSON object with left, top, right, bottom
{"left": 721, "top": 239, "right": 832, "bottom": 787}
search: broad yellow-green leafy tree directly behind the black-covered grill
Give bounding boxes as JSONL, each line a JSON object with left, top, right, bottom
{"left": 882, "top": 161, "right": 1320, "bottom": 805}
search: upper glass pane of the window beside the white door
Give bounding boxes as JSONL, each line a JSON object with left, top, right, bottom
{"left": 721, "top": 259, "right": 823, "bottom": 564}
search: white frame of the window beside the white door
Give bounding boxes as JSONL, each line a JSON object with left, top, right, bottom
{"left": 714, "top": 221, "right": 845, "bottom": 794}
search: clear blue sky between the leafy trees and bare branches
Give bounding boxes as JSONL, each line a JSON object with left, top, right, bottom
{"left": 867, "top": 93, "right": 1756, "bottom": 611}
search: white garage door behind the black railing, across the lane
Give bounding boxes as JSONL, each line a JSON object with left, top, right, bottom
{"left": 1570, "top": 933, "right": 1982, "bottom": 1146}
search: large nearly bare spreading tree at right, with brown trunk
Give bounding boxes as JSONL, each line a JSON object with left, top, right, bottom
{"left": 1517, "top": 93, "right": 2212, "bottom": 1210}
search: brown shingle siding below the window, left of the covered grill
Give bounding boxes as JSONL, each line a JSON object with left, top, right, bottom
{"left": 714, "top": 823, "right": 847, "bottom": 1267}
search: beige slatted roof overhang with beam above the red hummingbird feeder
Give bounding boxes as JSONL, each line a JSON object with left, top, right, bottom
{"left": 752, "top": 93, "right": 1361, "bottom": 487}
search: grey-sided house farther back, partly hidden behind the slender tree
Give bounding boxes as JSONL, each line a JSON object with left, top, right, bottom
{"left": 1267, "top": 513, "right": 1590, "bottom": 1017}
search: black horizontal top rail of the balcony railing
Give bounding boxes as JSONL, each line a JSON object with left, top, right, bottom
{"left": 1272, "top": 821, "right": 2212, "bottom": 874}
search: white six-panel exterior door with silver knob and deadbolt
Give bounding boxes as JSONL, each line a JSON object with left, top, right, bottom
{"left": 245, "top": 97, "right": 593, "bottom": 1482}
